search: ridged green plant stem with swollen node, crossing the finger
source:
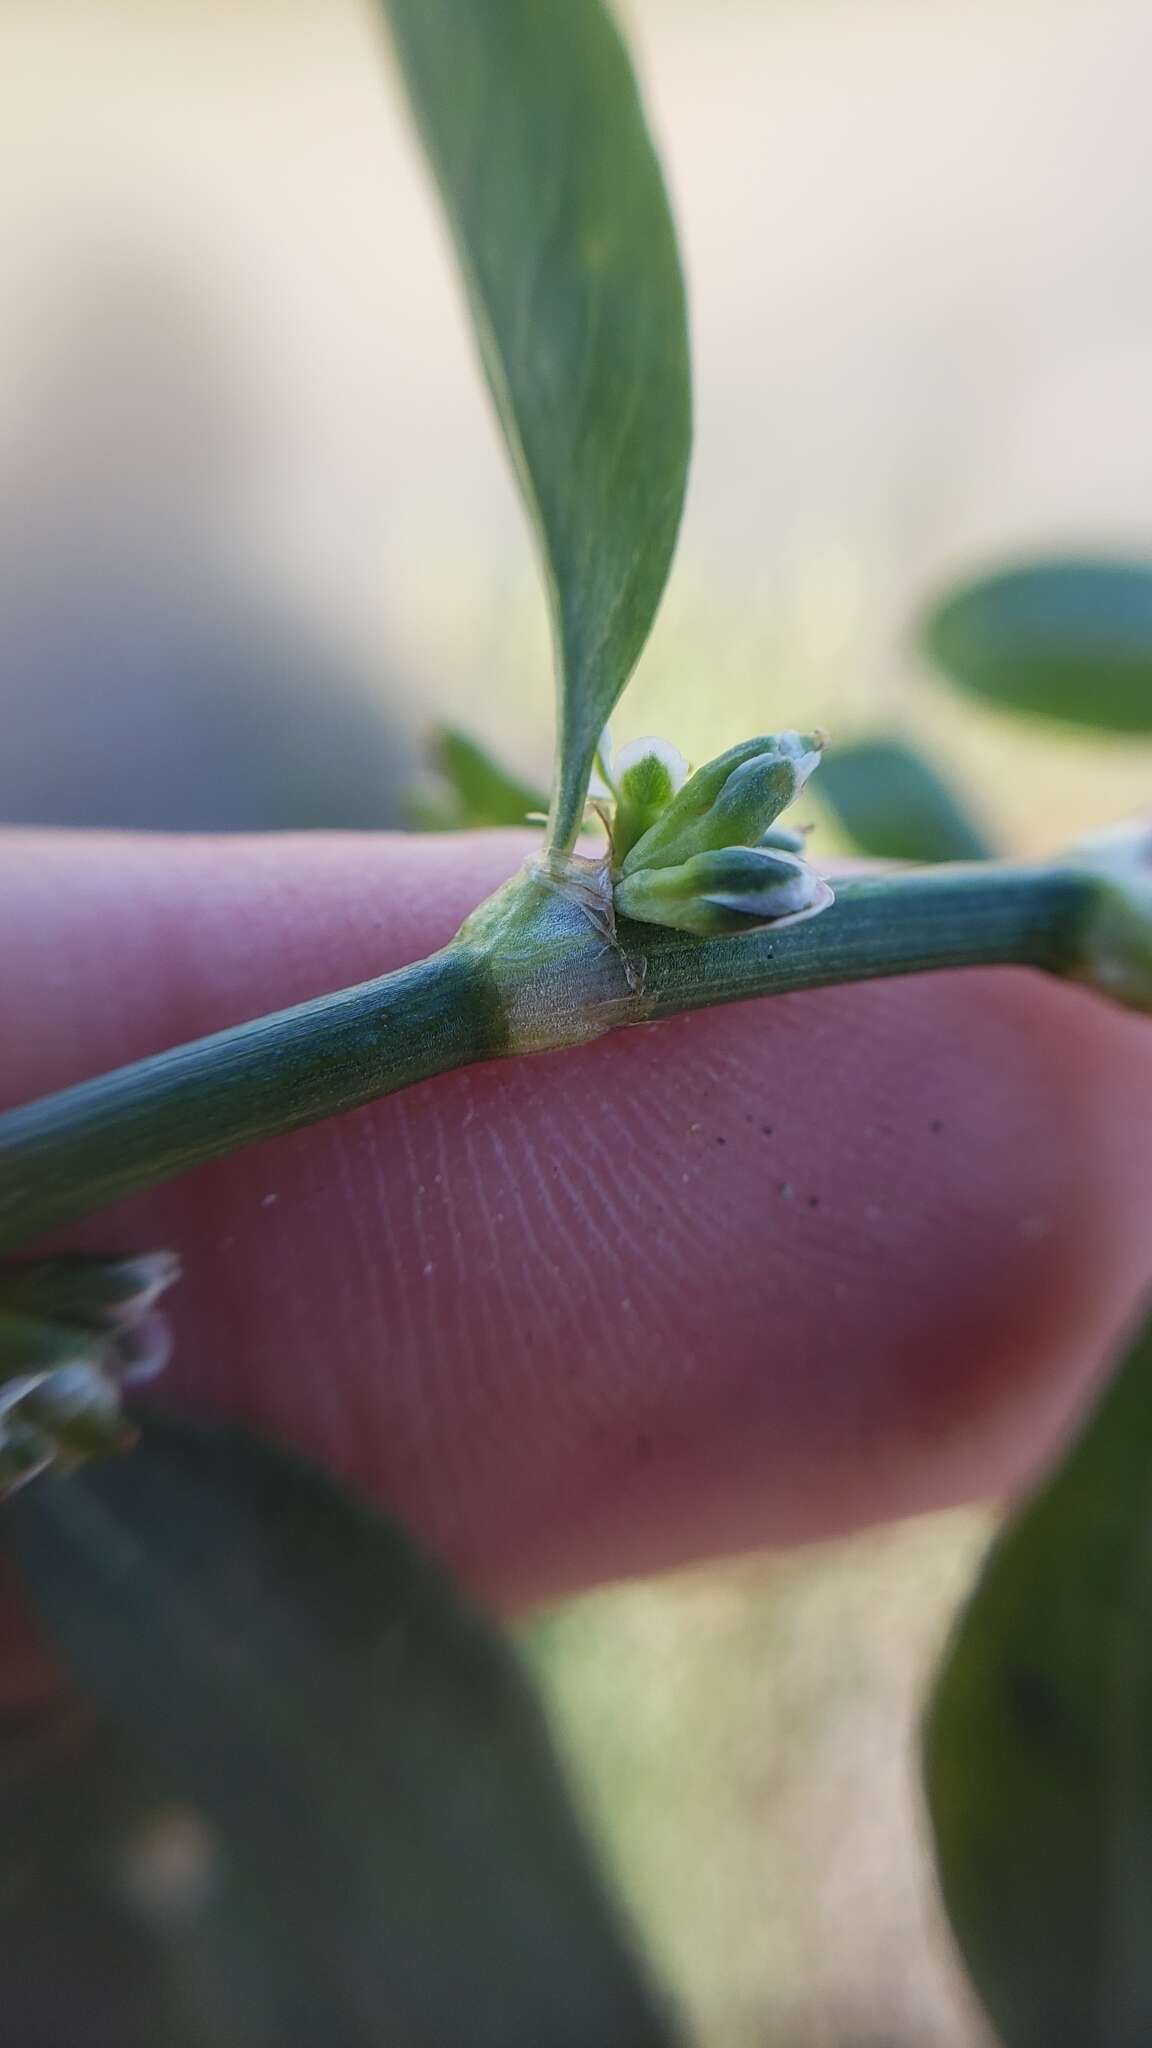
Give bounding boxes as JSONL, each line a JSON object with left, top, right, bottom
{"left": 0, "top": 864, "right": 1101, "bottom": 1249}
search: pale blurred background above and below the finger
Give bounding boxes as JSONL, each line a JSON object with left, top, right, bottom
{"left": 0, "top": 0, "right": 1152, "bottom": 2048}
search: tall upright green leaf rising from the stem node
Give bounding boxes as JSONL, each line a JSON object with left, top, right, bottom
{"left": 381, "top": 0, "right": 691, "bottom": 844}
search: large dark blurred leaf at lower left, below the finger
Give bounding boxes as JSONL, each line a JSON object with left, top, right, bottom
{"left": 0, "top": 1419, "right": 668, "bottom": 2048}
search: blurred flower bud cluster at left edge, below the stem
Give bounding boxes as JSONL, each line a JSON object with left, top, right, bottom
{"left": 0, "top": 1251, "right": 180, "bottom": 1497}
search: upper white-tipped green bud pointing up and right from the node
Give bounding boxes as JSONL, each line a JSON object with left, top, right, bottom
{"left": 619, "top": 733, "right": 824, "bottom": 874}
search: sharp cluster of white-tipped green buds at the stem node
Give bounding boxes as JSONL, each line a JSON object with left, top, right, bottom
{"left": 601, "top": 733, "right": 832, "bottom": 936}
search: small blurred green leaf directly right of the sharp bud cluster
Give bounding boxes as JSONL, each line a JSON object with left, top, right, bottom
{"left": 820, "top": 737, "right": 992, "bottom": 866}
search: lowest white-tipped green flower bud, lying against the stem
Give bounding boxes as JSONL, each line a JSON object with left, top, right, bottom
{"left": 615, "top": 846, "right": 832, "bottom": 936}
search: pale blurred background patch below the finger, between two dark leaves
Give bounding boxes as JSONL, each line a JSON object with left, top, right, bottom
{"left": 527, "top": 1513, "right": 988, "bottom": 2048}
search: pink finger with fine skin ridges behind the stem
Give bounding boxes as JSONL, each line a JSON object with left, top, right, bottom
{"left": 0, "top": 831, "right": 1152, "bottom": 1606}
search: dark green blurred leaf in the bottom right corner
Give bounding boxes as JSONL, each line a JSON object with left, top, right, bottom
{"left": 927, "top": 1323, "right": 1152, "bottom": 2048}
